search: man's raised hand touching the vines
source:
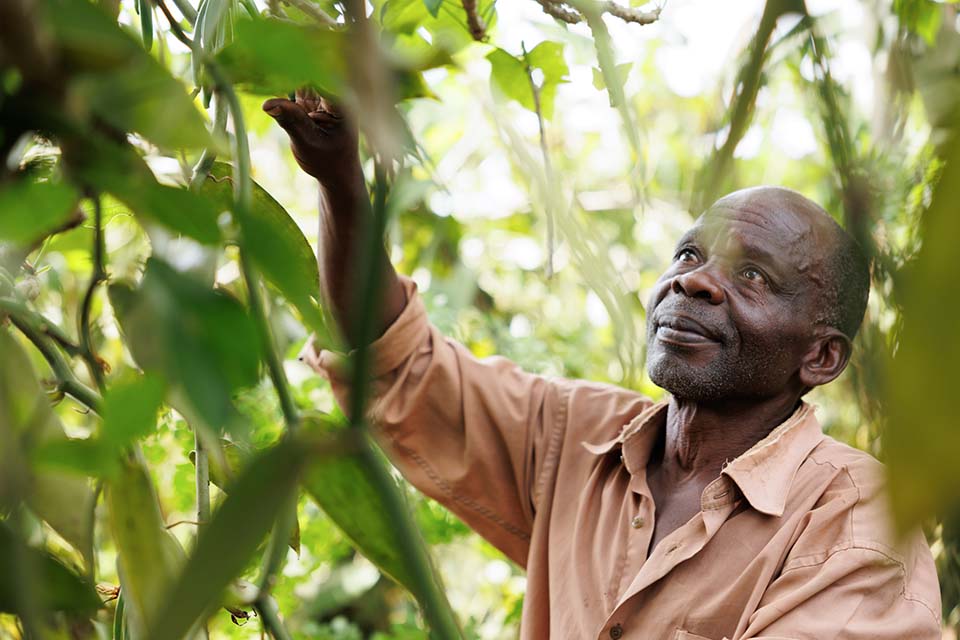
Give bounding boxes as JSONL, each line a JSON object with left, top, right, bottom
{"left": 263, "top": 90, "right": 363, "bottom": 192}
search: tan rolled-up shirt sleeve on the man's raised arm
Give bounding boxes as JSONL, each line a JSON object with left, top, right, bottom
{"left": 304, "top": 278, "right": 640, "bottom": 566}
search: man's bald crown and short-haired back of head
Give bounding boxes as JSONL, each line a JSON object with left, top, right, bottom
{"left": 704, "top": 186, "right": 870, "bottom": 340}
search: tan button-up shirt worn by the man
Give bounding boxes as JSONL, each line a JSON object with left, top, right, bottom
{"left": 307, "top": 279, "right": 940, "bottom": 640}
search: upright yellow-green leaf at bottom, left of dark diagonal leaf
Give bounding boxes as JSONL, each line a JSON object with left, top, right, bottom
{"left": 104, "top": 456, "right": 183, "bottom": 637}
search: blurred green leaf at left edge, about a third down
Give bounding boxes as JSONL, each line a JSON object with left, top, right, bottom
{"left": 0, "top": 179, "right": 80, "bottom": 246}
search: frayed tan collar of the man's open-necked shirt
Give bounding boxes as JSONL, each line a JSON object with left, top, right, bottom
{"left": 583, "top": 402, "right": 823, "bottom": 517}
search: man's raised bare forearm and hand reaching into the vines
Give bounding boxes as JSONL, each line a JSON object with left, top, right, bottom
{"left": 263, "top": 91, "right": 406, "bottom": 347}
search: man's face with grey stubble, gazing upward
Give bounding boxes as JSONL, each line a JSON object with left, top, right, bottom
{"left": 647, "top": 192, "right": 826, "bottom": 402}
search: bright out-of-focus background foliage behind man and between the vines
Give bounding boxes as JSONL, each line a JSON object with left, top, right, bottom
{"left": 0, "top": 0, "right": 960, "bottom": 639}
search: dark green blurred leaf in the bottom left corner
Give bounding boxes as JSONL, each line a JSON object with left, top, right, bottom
{"left": 0, "top": 520, "right": 103, "bottom": 615}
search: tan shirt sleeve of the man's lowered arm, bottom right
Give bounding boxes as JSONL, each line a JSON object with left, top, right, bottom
{"left": 743, "top": 542, "right": 941, "bottom": 640}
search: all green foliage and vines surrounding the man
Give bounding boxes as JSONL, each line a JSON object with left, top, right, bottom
{"left": 0, "top": 0, "right": 960, "bottom": 640}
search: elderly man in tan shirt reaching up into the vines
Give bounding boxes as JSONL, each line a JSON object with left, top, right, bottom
{"left": 264, "top": 96, "right": 940, "bottom": 640}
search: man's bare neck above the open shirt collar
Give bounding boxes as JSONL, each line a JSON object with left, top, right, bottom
{"left": 659, "top": 396, "right": 799, "bottom": 481}
